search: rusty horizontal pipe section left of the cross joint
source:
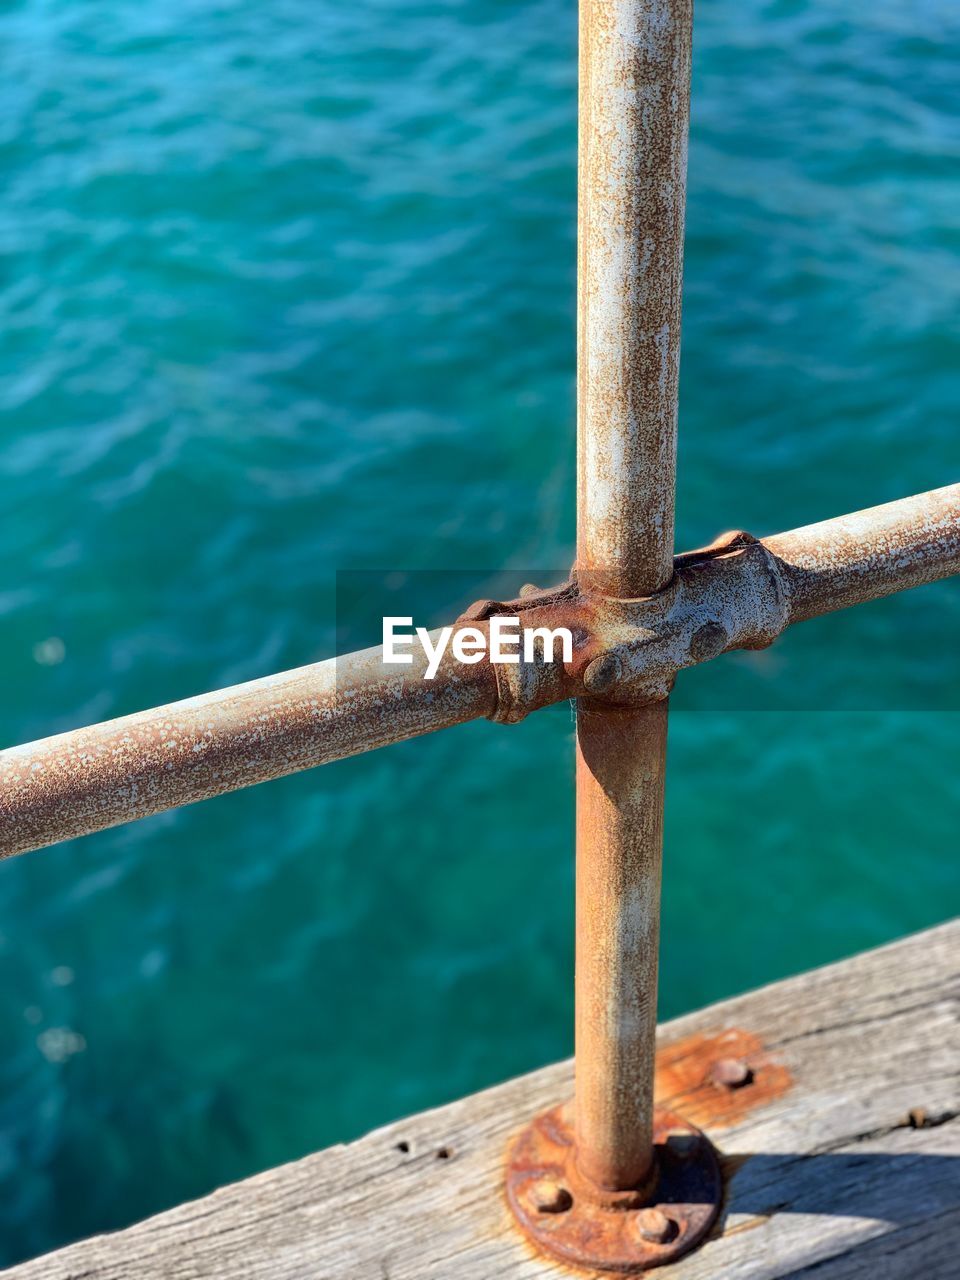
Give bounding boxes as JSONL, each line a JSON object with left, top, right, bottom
{"left": 0, "top": 646, "right": 497, "bottom": 858}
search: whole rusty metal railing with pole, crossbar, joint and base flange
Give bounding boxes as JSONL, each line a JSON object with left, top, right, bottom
{"left": 0, "top": 0, "right": 960, "bottom": 1271}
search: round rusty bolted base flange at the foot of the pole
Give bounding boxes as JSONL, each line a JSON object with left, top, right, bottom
{"left": 507, "top": 1105, "right": 722, "bottom": 1274}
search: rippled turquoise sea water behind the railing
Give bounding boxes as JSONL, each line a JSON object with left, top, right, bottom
{"left": 0, "top": 0, "right": 960, "bottom": 1263}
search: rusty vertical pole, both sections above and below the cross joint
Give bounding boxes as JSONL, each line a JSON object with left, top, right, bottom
{"left": 575, "top": 0, "right": 691, "bottom": 1189}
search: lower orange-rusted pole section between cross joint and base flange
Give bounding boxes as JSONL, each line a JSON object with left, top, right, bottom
{"left": 575, "top": 701, "right": 667, "bottom": 1189}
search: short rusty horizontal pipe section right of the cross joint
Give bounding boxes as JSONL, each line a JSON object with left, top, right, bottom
{"left": 763, "top": 484, "right": 960, "bottom": 622}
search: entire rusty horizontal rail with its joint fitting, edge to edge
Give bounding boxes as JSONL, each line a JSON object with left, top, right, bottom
{"left": 0, "top": 485, "right": 960, "bottom": 856}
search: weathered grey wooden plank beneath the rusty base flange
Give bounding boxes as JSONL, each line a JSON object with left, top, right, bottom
{"left": 5, "top": 923, "right": 960, "bottom": 1280}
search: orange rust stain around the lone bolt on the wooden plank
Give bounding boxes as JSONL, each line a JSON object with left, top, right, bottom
{"left": 654, "top": 1027, "right": 794, "bottom": 1130}
